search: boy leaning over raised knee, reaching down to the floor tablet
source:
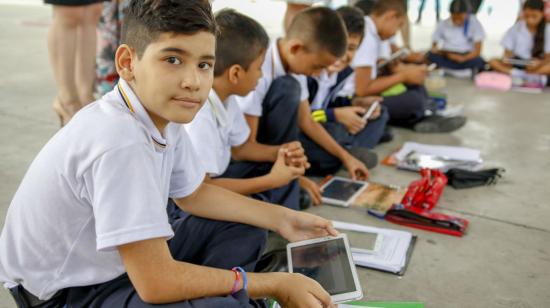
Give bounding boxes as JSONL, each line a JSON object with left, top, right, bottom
{"left": 233, "top": 7, "right": 375, "bottom": 184}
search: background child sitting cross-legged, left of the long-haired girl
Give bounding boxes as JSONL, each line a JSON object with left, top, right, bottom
{"left": 428, "top": 0, "right": 485, "bottom": 74}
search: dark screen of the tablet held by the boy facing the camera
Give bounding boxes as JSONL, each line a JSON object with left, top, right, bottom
{"left": 291, "top": 238, "right": 356, "bottom": 295}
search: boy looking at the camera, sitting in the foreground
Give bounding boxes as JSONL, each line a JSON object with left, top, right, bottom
{"left": 0, "top": 0, "right": 336, "bottom": 308}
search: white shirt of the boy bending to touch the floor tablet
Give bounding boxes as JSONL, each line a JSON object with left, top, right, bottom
{"left": 233, "top": 40, "right": 308, "bottom": 117}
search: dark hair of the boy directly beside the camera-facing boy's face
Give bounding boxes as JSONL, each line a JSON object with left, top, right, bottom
{"left": 214, "top": 9, "right": 269, "bottom": 77}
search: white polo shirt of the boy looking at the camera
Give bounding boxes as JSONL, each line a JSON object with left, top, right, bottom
{"left": 0, "top": 80, "right": 204, "bottom": 300}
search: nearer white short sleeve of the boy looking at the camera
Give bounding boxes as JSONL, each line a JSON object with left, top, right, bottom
{"left": 88, "top": 143, "right": 173, "bottom": 251}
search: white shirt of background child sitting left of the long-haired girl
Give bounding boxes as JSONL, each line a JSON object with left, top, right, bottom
{"left": 432, "top": 15, "right": 485, "bottom": 53}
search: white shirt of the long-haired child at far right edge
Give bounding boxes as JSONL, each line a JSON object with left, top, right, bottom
{"left": 501, "top": 20, "right": 550, "bottom": 60}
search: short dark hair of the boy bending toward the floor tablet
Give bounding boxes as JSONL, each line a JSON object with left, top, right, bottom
{"left": 287, "top": 7, "right": 348, "bottom": 58}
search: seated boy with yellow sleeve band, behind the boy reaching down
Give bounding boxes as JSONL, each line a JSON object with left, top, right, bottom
{"left": 300, "top": 6, "right": 389, "bottom": 183}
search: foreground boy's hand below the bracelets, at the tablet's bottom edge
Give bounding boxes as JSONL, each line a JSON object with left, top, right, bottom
{"left": 274, "top": 273, "right": 336, "bottom": 308}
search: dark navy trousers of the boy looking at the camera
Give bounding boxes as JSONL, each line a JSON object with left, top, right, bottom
{"left": 14, "top": 215, "right": 267, "bottom": 308}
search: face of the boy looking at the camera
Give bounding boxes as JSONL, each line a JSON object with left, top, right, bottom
{"left": 116, "top": 31, "right": 216, "bottom": 127}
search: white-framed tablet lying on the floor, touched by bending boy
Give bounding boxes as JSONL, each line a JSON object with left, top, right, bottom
{"left": 321, "top": 176, "right": 368, "bottom": 207}
